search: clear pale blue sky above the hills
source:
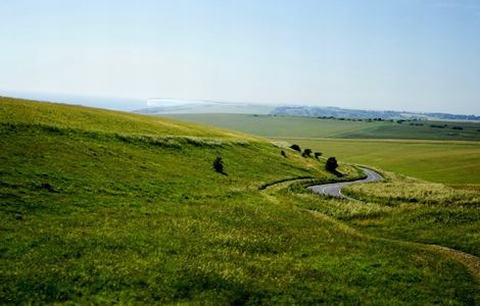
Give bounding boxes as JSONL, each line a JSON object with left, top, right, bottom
{"left": 0, "top": 0, "right": 480, "bottom": 114}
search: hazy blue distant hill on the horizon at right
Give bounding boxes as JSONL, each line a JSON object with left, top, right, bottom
{"left": 271, "top": 106, "right": 480, "bottom": 121}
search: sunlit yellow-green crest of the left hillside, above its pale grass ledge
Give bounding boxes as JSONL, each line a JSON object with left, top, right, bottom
{"left": 0, "top": 97, "right": 254, "bottom": 140}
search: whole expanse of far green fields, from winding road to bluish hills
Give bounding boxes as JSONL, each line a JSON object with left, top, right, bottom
{"left": 169, "top": 114, "right": 480, "bottom": 185}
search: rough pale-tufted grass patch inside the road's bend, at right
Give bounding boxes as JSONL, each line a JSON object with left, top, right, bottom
{"left": 286, "top": 172, "right": 480, "bottom": 258}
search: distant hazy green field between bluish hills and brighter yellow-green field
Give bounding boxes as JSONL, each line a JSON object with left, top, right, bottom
{"left": 169, "top": 114, "right": 480, "bottom": 140}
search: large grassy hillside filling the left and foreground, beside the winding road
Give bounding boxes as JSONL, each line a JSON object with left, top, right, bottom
{"left": 0, "top": 98, "right": 480, "bottom": 305}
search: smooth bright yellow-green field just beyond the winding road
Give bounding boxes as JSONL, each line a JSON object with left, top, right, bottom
{"left": 280, "top": 139, "right": 480, "bottom": 185}
